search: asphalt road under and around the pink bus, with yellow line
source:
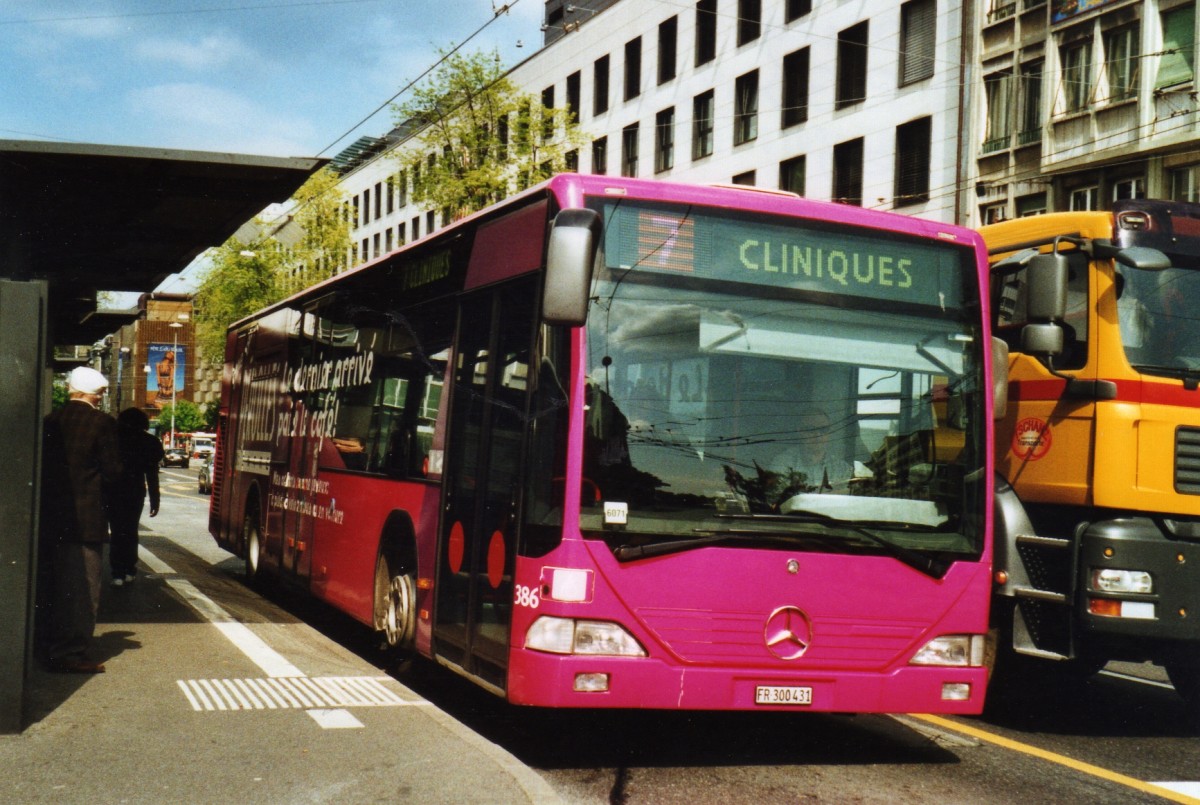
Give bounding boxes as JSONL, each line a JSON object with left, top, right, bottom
{"left": 154, "top": 467, "right": 1200, "bottom": 805}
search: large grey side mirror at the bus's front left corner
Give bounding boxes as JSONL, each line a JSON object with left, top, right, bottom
{"left": 541, "top": 210, "right": 602, "bottom": 328}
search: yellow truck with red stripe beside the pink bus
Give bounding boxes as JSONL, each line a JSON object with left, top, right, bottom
{"left": 982, "top": 200, "right": 1200, "bottom": 726}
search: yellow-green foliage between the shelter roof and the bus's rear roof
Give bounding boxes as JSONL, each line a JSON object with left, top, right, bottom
{"left": 194, "top": 169, "right": 350, "bottom": 364}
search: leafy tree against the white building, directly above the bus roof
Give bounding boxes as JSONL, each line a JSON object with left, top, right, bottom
{"left": 392, "top": 53, "right": 587, "bottom": 218}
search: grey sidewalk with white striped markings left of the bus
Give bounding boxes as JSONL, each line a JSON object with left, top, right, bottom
{"left": 0, "top": 534, "right": 558, "bottom": 804}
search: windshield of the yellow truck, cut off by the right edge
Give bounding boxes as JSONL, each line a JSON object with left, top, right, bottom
{"left": 1117, "top": 268, "right": 1200, "bottom": 377}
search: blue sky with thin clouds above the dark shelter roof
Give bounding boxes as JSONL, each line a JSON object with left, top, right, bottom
{"left": 0, "top": 0, "right": 544, "bottom": 157}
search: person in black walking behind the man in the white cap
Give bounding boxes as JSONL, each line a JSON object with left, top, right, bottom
{"left": 108, "top": 408, "right": 163, "bottom": 587}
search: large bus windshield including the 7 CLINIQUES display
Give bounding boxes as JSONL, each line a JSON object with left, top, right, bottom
{"left": 581, "top": 202, "right": 986, "bottom": 566}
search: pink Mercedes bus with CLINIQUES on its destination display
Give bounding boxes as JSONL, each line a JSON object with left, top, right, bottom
{"left": 210, "top": 175, "right": 1004, "bottom": 713}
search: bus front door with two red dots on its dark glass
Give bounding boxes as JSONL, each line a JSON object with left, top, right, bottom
{"left": 433, "top": 282, "right": 536, "bottom": 690}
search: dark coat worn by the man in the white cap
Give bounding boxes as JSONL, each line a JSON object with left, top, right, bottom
{"left": 42, "top": 400, "right": 121, "bottom": 542}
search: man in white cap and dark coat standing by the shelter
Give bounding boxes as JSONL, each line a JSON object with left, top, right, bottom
{"left": 38, "top": 366, "right": 121, "bottom": 673}
